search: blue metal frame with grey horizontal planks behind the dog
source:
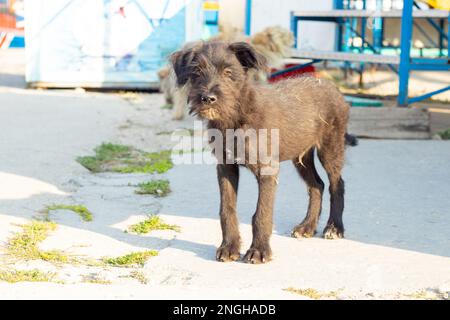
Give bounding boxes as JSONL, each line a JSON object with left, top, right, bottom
{"left": 291, "top": 0, "right": 450, "bottom": 106}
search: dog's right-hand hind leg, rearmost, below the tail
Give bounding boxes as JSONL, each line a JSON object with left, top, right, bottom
{"left": 318, "top": 131, "right": 345, "bottom": 239}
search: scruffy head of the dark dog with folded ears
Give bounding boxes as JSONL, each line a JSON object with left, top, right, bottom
{"left": 170, "top": 41, "right": 266, "bottom": 121}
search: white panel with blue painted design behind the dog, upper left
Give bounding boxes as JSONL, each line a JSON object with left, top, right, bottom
{"left": 25, "top": 0, "right": 203, "bottom": 88}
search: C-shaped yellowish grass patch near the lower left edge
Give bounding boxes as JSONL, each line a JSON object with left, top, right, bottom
{"left": 6, "top": 220, "right": 69, "bottom": 263}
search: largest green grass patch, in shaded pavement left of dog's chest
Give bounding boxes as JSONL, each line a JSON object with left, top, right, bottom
{"left": 77, "top": 143, "right": 173, "bottom": 173}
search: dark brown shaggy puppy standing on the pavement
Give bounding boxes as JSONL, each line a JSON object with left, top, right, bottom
{"left": 171, "top": 42, "right": 349, "bottom": 263}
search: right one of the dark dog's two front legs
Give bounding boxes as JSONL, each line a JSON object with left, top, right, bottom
{"left": 244, "top": 171, "right": 278, "bottom": 263}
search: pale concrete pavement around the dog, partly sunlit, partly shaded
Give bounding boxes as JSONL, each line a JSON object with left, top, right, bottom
{"left": 0, "top": 88, "right": 450, "bottom": 298}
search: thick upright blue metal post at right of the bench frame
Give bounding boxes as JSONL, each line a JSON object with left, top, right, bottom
{"left": 398, "top": 0, "right": 413, "bottom": 106}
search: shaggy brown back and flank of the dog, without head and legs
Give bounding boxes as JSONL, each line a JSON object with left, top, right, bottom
{"left": 250, "top": 77, "right": 349, "bottom": 161}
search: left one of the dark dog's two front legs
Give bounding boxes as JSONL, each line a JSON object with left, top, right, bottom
{"left": 216, "top": 164, "right": 241, "bottom": 262}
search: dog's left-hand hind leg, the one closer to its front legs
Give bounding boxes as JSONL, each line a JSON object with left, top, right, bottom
{"left": 292, "top": 148, "right": 324, "bottom": 238}
